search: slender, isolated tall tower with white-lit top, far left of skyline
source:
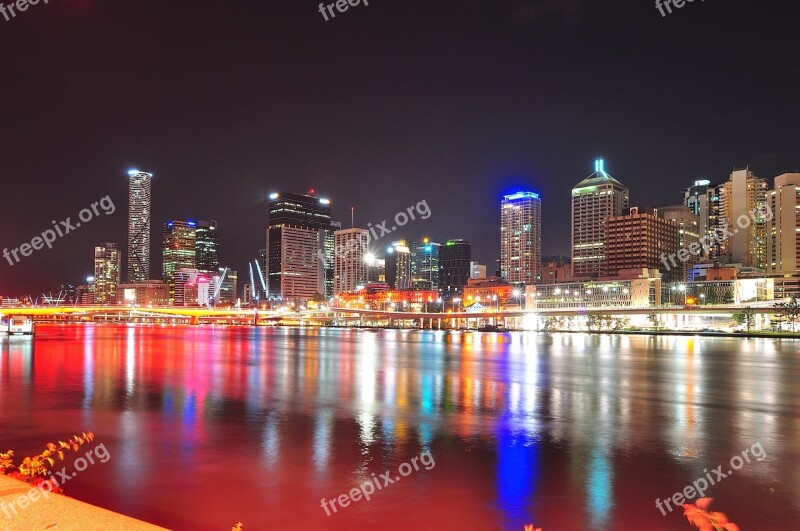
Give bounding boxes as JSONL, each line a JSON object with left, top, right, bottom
{"left": 128, "top": 170, "right": 153, "bottom": 282}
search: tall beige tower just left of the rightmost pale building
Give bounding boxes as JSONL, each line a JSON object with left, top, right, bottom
{"left": 720, "top": 168, "right": 767, "bottom": 269}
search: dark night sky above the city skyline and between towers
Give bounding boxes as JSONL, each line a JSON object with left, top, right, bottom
{"left": 0, "top": 0, "right": 800, "bottom": 294}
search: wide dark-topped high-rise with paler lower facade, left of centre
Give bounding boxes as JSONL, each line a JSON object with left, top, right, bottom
{"left": 267, "top": 190, "right": 332, "bottom": 302}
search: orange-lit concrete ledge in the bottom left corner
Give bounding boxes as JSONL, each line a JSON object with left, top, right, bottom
{"left": 0, "top": 476, "right": 164, "bottom": 531}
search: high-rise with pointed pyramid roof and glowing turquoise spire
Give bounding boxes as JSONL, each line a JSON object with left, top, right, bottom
{"left": 572, "top": 159, "right": 629, "bottom": 277}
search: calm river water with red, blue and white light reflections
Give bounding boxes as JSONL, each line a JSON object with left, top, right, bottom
{"left": 0, "top": 326, "right": 800, "bottom": 531}
